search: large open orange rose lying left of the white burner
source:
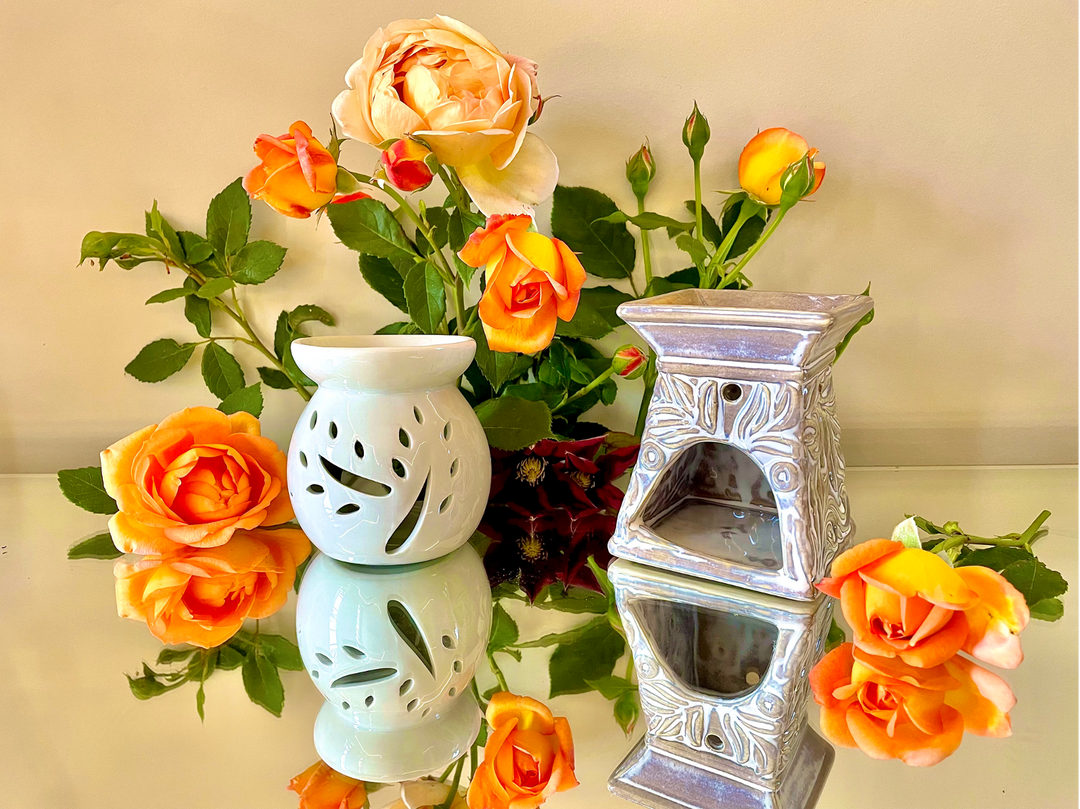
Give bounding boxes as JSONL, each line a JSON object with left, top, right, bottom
{"left": 102, "top": 407, "right": 293, "bottom": 554}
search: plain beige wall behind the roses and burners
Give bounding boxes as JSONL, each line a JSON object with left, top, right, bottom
{"left": 0, "top": 0, "right": 1080, "bottom": 472}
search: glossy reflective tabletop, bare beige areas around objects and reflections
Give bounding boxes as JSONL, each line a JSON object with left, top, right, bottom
{"left": 0, "top": 467, "right": 1080, "bottom": 809}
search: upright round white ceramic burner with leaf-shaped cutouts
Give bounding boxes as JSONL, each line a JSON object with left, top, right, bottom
{"left": 288, "top": 335, "right": 491, "bottom": 565}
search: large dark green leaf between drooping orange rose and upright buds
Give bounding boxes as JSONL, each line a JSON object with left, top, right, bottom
{"left": 551, "top": 186, "right": 637, "bottom": 278}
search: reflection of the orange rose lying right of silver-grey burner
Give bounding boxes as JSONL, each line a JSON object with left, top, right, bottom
{"left": 810, "top": 644, "right": 1016, "bottom": 767}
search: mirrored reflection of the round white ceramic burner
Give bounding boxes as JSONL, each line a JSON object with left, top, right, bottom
{"left": 296, "top": 544, "right": 491, "bottom": 782}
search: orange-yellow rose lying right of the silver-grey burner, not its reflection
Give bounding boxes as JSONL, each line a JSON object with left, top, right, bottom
{"left": 818, "top": 539, "right": 1029, "bottom": 669}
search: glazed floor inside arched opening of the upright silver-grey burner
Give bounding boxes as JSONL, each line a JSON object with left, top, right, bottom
{"left": 649, "top": 497, "right": 783, "bottom": 570}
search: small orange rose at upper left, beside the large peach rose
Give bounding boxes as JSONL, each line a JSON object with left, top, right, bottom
{"left": 244, "top": 121, "right": 337, "bottom": 219}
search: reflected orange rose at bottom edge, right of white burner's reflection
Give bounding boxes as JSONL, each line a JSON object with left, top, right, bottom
{"left": 468, "top": 691, "right": 578, "bottom": 809}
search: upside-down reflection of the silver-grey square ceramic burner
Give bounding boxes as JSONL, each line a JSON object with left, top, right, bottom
{"left": 608, "top": 559, "right": 833, "bottom": 809}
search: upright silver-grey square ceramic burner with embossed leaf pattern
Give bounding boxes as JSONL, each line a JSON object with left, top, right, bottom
{"left": 609, "top": 289, "right": 874, "bottom": 601}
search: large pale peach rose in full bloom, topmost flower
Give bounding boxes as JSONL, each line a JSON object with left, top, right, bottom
{"left": 334, "top": 16, "right": 558, "bottom": 214}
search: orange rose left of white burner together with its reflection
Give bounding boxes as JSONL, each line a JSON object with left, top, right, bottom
{"left": 102, "top": 407, "right": 311, "bottom": 649}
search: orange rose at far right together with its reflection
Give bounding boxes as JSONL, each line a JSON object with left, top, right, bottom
{"left": 810, "top": 539, "right": 1029, "bottom": 767}
